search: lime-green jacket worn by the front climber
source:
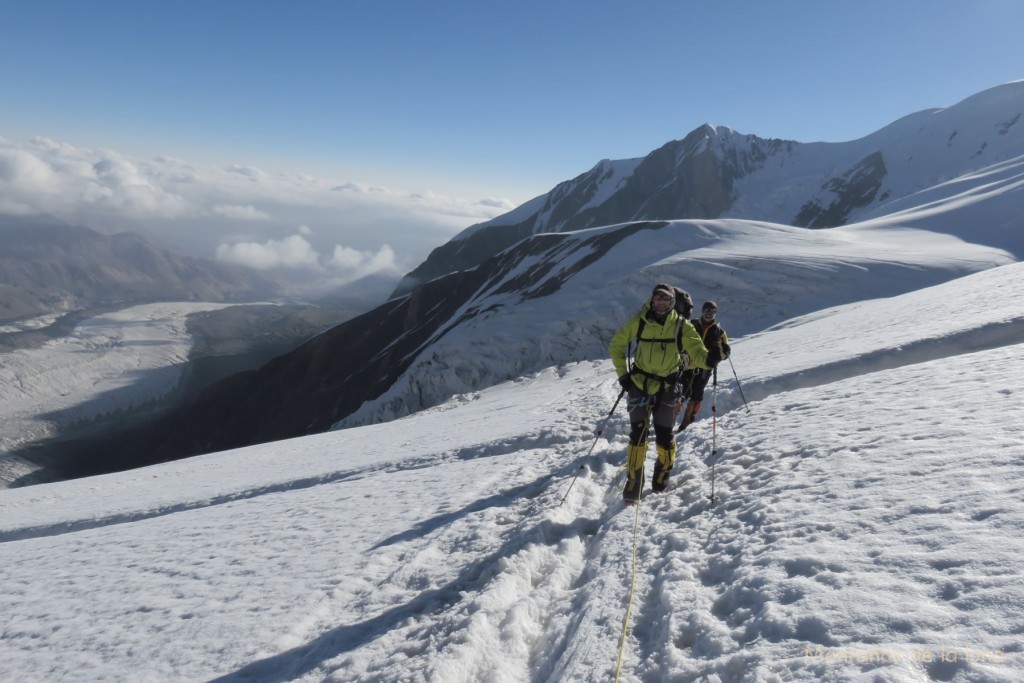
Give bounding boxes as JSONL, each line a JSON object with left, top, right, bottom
{"left": 608, "top": 301, "right": 708, "bottom": 393}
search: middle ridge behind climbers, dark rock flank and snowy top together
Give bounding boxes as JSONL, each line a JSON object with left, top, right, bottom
{"left": 66, "top": 221, "right": 1012, "bottom": 469}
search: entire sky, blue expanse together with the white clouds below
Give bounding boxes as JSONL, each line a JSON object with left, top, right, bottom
{"left": 0, "top": 0, "right": 1024, "bottom": 289}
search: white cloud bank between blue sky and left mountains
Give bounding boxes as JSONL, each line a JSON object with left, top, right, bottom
{"left": 0, "top": 137, "right": 514, "bottom": 292}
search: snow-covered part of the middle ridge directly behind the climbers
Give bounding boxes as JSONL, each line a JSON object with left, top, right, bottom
{"left": 338, "top": 219, "right": 1014, "bottom": 427}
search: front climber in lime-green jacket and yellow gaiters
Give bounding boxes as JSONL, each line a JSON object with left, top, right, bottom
{"left": 608, "top": 284, "right": 722, "bottom": 502}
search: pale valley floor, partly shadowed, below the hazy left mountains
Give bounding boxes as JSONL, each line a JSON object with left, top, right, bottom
{"left": 0, "top": 302, "right": 354, "bottom": 487}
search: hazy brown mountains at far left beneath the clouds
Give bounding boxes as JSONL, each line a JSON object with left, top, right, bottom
{"left": 0, "top": 216, "right": 287, "bottom": 322}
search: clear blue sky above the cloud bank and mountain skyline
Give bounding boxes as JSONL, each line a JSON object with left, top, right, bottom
{"left": 0, "top": 0, "right": 1024, "bottom": 202}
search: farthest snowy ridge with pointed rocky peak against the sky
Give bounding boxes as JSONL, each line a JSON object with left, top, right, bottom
{"left": 396, "top": 81, "right": 1024, "bottom": 294}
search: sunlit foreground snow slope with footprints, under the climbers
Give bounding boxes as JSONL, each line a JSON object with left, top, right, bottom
{"left": 0, "top": 264, "right": 1024, "bottom": 681}
